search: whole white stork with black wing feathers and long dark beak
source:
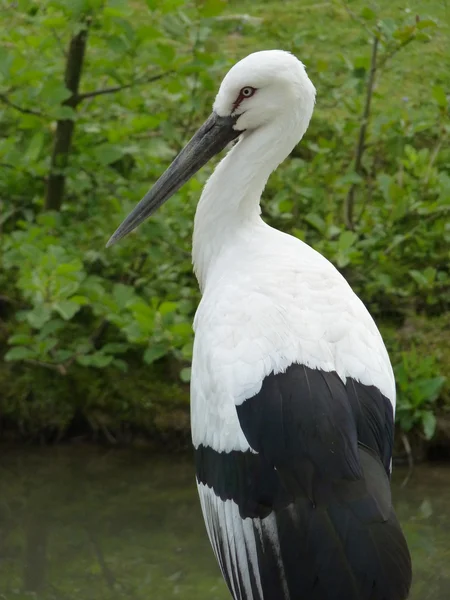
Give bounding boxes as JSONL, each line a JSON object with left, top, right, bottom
{"left": 108, "top": 50, "right": 412, "bottom": 600}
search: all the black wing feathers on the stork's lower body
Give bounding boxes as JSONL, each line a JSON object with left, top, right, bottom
{"left": 196, "top": 364, "right": 411, "bottom": 600}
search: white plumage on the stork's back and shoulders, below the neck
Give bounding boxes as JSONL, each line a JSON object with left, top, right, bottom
{"left": 191, "top": 227, "right": 395, "bottom": 451}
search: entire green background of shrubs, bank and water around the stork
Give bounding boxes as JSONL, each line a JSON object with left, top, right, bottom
{"left": 0, "top": 0, "right": 450, "bottom": 600}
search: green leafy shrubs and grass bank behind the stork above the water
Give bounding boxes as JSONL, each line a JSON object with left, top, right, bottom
{"left": 0, "top": 0, "right": 450, "bottom": 448}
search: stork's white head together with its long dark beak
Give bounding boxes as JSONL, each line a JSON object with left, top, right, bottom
{"left": 107, "top": 50, "right": 315, "bottom": 246}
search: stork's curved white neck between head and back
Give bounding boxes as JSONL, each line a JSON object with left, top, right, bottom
{"left": 192, "top": 120, "right": 307, "bottom": 290}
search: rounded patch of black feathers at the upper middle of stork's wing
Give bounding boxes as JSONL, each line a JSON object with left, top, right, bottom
{"left": 237, "top": 365, "right": 361, "bottom": 488}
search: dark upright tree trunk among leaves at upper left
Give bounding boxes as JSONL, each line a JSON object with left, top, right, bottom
{"left": 45, "top": 20, "right": 89, "bottom": 211}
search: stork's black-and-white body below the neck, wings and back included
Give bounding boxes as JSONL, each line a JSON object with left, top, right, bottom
{"left": 192, "top": 230, "right": 411, "bottom": 600}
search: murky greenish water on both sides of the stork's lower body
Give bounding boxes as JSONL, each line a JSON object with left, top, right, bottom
{"left": 0, "top": 447, "right": 450, "bottom": 600}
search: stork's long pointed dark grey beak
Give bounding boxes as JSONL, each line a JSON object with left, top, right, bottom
{"left": 106, "top": 112, "right": 242, "bottom": 247}
